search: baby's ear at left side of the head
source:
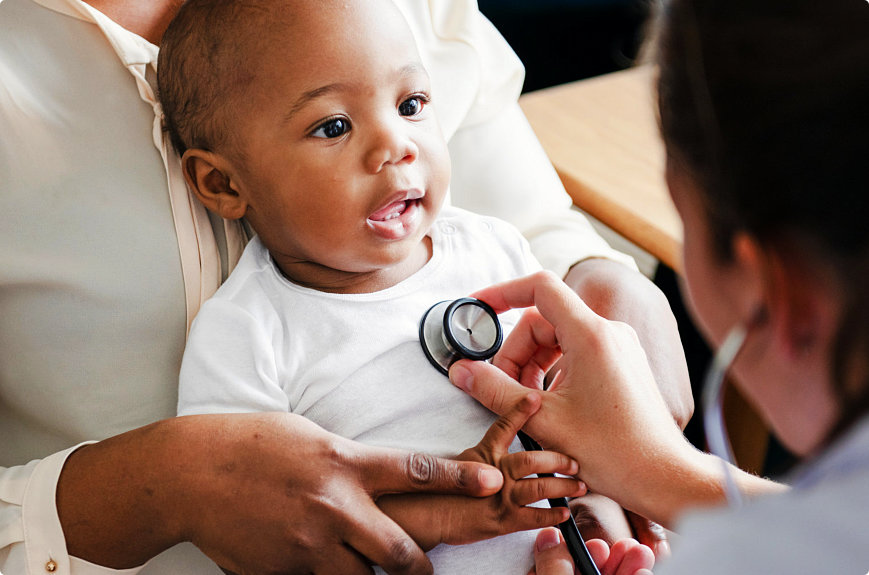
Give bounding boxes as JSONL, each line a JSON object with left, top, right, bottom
{"left": 181, "top": 148, "right": 247, "bottom": 220}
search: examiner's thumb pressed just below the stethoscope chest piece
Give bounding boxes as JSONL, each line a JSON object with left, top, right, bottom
{"left": 450, "top": 359, "right": 532, "bottom": 415}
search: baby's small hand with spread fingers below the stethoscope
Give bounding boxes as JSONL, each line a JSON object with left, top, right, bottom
{"left": 441, "top": 395, "right": 586, "bottom": 545}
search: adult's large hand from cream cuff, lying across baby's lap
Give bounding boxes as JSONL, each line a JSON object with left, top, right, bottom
{"left": 57, "top": 413, "right": 503, "bottom": 574}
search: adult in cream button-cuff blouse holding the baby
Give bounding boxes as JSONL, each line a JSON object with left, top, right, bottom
{"left": 0, "top": 0, "right": 691, "bottom": 574}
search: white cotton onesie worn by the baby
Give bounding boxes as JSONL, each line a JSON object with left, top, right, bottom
{"left": 178, "top": 208, "right": 539, "bottom": 575}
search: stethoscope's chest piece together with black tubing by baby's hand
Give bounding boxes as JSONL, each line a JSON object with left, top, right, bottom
{"left": 419, "top": 297, "right": 600, "bottom": 575}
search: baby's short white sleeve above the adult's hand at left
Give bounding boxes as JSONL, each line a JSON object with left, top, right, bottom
{"left": 178, "top": 299, "right": 290, "bottom": 415}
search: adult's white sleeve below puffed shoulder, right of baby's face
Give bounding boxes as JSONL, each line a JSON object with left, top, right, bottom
{"left": 449, "top": 102, "right": 636, "bottom": 277}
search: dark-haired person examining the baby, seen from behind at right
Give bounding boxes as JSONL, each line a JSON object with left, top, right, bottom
{"left": 450, "top": 0, "right": 869, "bottom": 575}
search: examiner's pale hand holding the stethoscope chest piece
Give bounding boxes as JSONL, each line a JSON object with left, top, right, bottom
{"left": 450, "top": 272, "right": 695, "bottom": 524}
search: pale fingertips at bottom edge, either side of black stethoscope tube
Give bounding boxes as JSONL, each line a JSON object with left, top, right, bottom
{"left": 529, "top": 529, "right": 655, "bottom": 575}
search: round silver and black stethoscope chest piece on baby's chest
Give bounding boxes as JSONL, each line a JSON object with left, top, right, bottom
{"left": 419, "top": 297, "right": 503, "bottom": 375}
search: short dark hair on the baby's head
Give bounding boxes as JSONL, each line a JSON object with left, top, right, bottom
{"left": 157, "top": 0, "right": 274, "bottom": 155}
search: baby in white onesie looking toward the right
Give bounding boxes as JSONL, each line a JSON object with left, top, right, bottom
{"left": 158, "top": 0, "right": 579, "bottom": 575}
